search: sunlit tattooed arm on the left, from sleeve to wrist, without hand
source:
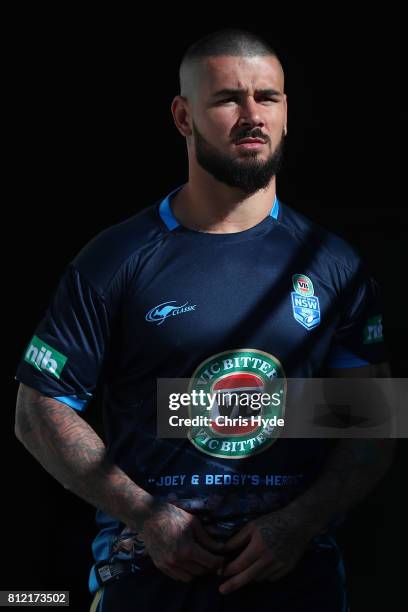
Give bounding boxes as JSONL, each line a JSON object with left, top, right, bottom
{"left": 16, "top": 385, "right": 153, "bottom": 530}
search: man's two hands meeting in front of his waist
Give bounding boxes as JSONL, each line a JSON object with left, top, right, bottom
{"left": 141, "top": 504, "right": 313, "bottom": 594}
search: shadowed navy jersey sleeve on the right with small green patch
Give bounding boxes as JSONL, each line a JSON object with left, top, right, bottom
{"left": 327, "top": 262, "right": 388, "bottom": 368}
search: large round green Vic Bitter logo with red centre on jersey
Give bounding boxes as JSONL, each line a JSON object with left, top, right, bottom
{"left": 189, "top": 348, "right": 286, "bottom": 459}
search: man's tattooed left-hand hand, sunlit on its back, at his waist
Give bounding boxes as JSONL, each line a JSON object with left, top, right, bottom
{"left": 141, "top": 504, "right": 224, "bottom": 582}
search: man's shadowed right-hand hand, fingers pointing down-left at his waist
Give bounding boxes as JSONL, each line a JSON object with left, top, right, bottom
{"left": 219, "top": 510, "right": 313, "bottom": 594}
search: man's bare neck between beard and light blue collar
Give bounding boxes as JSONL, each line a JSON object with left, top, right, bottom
{"left": 171, "top": 177, "right": 276, "bottom": 234}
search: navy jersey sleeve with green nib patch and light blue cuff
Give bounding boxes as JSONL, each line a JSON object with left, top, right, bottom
{"left": 15, "top": 264, "right": 111, "bottom": 410}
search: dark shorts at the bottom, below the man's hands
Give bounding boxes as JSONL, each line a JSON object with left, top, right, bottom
{"left": 98, "top": 546, "right": 348, "bottom": 612}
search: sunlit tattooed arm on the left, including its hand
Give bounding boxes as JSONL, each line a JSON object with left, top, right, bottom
{"left": 15, "top": 384, "right": 222, "bottom": 582}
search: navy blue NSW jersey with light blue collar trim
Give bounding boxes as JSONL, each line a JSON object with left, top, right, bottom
{"left": 16, "top": 188, "right": 385, "bottom": 590}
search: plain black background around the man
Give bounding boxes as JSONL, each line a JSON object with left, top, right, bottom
{"left": 0, "top": 5, "right": 408, "bottom": 612}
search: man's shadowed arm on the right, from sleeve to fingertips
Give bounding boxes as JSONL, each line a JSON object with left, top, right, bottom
{"left": 220, "top": 364, "right": 395, "bottom": 593}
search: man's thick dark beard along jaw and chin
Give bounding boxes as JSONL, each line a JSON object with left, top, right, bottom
{"left": 193, "top": 122, "right": 284, "bottom": 195}
